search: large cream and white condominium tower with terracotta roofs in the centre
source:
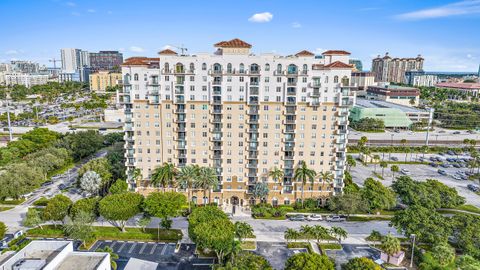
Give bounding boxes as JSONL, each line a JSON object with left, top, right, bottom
{"left": 120, "top": 39, "right": 353, "bottom": 205}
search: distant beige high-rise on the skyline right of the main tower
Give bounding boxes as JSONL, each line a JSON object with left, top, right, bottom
{"left": 372, "top": 53, "right": 424, "bottom": 83}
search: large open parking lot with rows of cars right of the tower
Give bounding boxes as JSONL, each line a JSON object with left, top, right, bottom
{"left": 351, "top": 154, "right": 480, "bottom": 207}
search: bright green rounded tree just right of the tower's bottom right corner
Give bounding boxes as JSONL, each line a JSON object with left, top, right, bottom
{"left": 361, "top": 178, "right": 396, "bottom": 211}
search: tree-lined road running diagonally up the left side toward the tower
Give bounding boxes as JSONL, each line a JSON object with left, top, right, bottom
{"left": 0, "top": 150, "right": 107, "bottom": 232}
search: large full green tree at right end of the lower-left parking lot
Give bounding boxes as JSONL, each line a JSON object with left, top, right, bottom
{"left": 194, "top": 219, "right": 235, "bottom": 264}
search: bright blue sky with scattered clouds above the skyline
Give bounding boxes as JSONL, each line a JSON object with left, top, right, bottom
{"left": 0, "top": 0, "right": 480, "bottom": 72}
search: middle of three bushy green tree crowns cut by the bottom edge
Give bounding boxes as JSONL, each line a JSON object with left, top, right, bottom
{"left": 285, "top": 252, "right": 335, "bottom": 270}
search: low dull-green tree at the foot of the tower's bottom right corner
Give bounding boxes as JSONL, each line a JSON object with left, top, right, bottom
{"left": 328, "top": 193, "right": 368, "bottom": 216}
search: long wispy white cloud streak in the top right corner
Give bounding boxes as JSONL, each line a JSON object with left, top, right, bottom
{"left": 395, "top": 0, "right": 480, "bottom": 20}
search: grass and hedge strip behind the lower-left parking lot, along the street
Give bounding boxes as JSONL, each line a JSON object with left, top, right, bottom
{"left": 27, "top": 225, "right": 182, "bottom": 242}
